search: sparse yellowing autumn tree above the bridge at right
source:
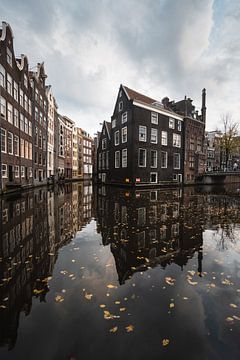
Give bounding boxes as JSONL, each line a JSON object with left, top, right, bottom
{"left": 220, "top": 113, "right": 240, "bottom": 167}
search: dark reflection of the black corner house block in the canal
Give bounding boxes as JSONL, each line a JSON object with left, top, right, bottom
{"left": 94, "top": 187, "right": 202, "bottom": 284}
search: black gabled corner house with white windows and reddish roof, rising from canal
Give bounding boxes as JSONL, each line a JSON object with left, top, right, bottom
{"left": 98, "top": 85, "right": 183, "bottom": 186}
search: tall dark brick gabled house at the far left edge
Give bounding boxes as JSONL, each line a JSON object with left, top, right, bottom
{"left": 0, "top": 22, "right": 33, "bottom": 191}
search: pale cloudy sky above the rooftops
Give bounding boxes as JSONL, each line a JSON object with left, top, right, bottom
{"left": 0, "top": 0, "right": 240, "bottom": 134}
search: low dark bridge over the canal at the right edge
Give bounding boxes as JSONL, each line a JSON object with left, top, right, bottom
{"left": 196, "top": 169, "right": 240, "bottom": 185}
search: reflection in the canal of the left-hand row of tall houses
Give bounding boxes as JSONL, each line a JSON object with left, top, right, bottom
{"left": 0, "top": 183, "right": 92, "bottom": 349}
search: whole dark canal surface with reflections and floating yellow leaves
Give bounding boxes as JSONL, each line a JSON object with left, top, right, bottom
{"left": 0, "top": 183, "right": 240, "bottom": 360}
